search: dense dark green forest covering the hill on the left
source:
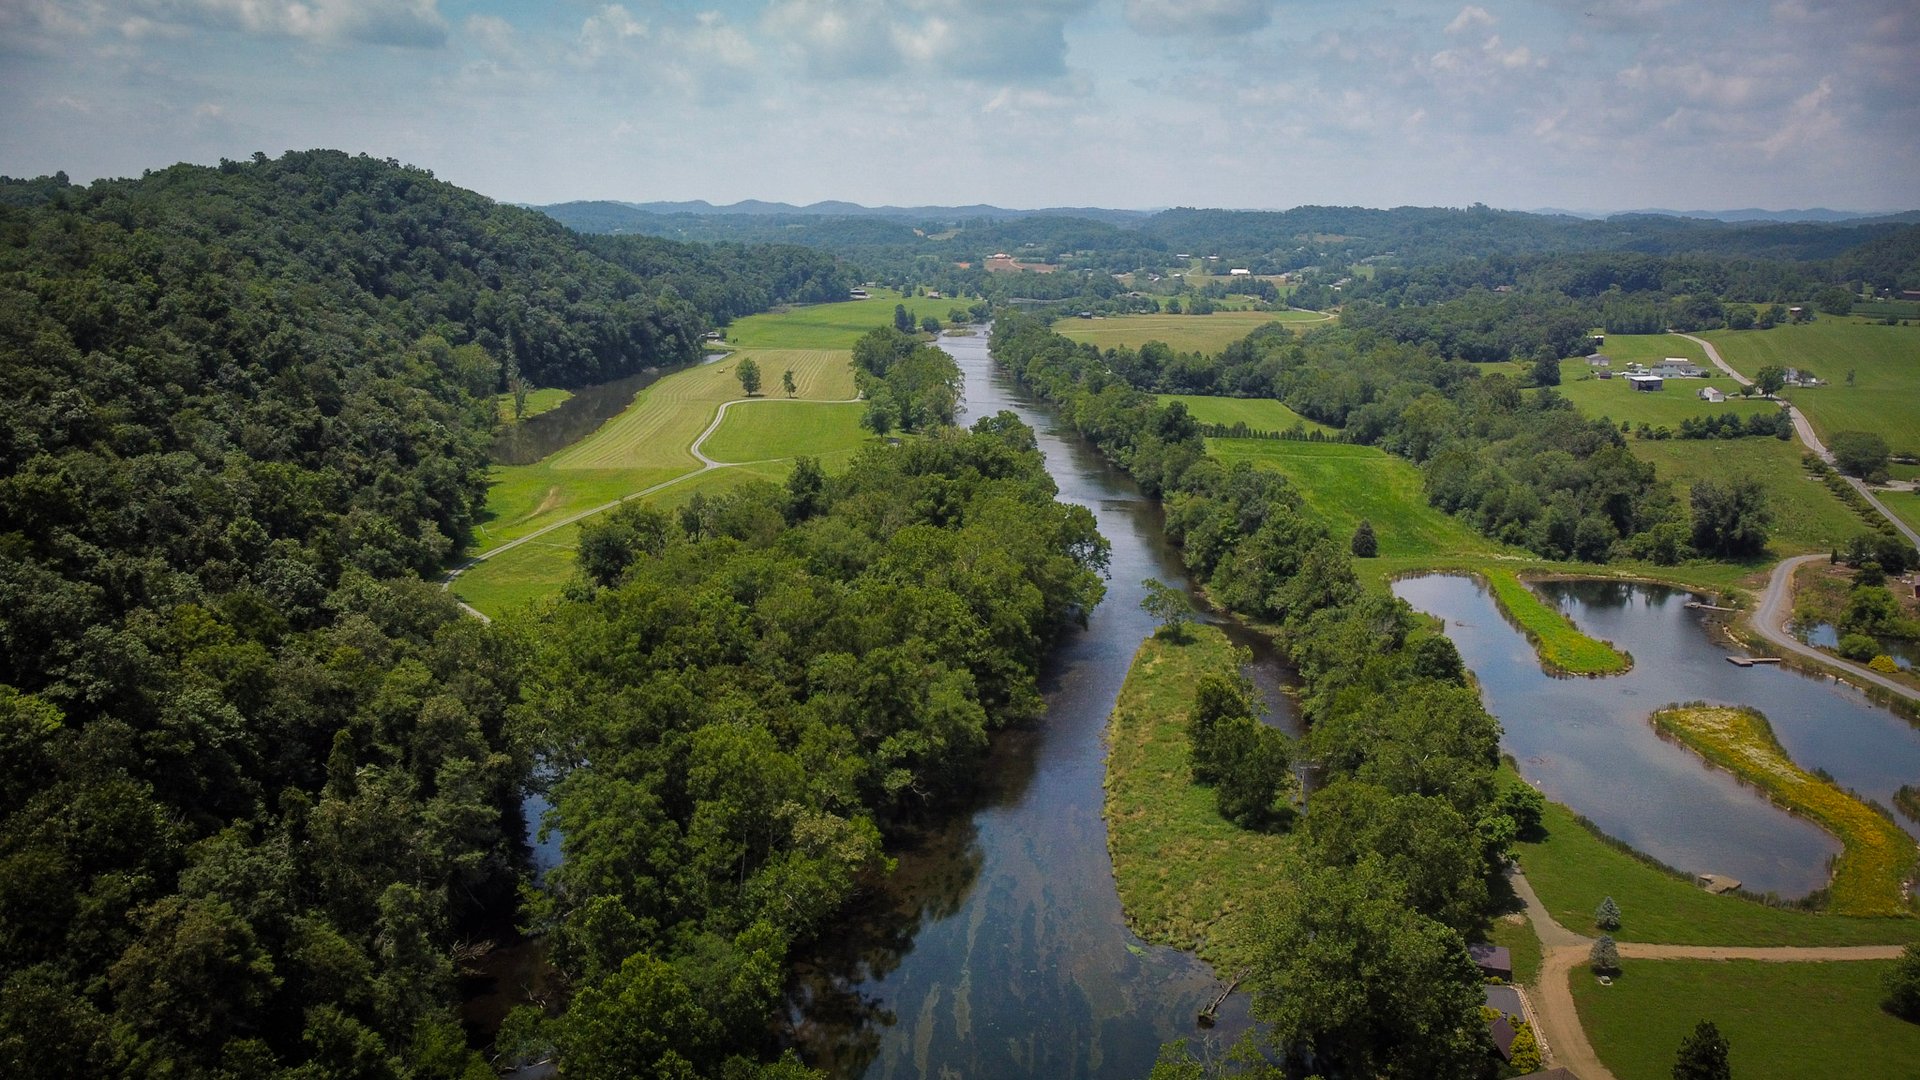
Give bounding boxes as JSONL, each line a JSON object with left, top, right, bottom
{"left": 0, "top": 152, "right": 875, "bottom": 1078}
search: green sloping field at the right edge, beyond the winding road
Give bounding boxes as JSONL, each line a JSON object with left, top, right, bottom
{"left": 1703, "top": 319, "right": 1920, "bottom": 454}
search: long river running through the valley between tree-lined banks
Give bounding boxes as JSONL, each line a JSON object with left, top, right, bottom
{"left": 789, "top": 336, "right": 1298, "bottom": 1078}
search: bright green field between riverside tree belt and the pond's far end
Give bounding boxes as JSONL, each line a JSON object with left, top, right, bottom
{"left": 1206, "top": 438, "right": 1501, "bottom": 553}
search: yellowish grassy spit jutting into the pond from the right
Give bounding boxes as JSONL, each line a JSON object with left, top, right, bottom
{"left": 1651, "top": 703, "right": 1920, "bottom": 915}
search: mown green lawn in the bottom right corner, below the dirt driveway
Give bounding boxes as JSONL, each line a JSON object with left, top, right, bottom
{"left": 1572, "top": 961, "right": 1920, "bottom": 1080}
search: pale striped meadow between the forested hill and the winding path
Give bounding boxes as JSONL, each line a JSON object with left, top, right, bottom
{"left": 474, "top": 350, "right": 854, "bottom": 553}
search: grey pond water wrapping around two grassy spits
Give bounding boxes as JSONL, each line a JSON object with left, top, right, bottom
{"left": 1394, "top": 577, "right": 1920, "bottom": 897}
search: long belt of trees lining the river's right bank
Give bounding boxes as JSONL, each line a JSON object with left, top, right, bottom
{"left": 993, "top": 317, "right": 1540, "bottom": 1078}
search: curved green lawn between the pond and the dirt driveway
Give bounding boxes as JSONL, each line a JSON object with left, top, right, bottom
{"left": 1515, "top": 791, "right": 1920, "bottom": 945}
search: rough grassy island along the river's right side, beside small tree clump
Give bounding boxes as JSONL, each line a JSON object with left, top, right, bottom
{"left": 1104, "top": 626, "right": 1290, "bottom": 972}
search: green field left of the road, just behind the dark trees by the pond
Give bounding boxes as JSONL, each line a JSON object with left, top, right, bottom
{"left": 1628, "top": 438, "right": 1866, "bottom": 557}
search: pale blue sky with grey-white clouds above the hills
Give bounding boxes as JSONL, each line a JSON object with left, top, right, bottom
{"left": 0, "top": 0, "right": 1920, "bottom": 209}
